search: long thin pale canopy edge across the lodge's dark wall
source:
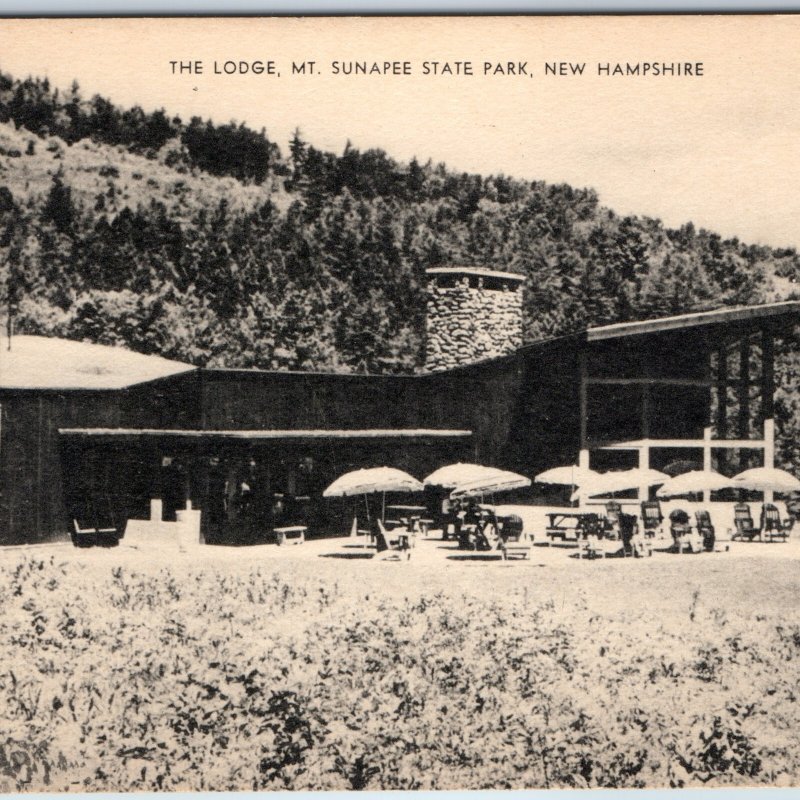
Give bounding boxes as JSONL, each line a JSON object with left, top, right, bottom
{"left": 58, "top": 428, "right": 472, "bottom": 439}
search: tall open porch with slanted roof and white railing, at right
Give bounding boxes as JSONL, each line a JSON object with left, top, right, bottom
{"left": 578, "top": 302, "right": 800, "bottom": 504}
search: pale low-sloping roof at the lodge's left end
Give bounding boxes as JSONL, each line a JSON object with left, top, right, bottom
{"left": 0, "top": 335, "right": 195, "bottom": 389}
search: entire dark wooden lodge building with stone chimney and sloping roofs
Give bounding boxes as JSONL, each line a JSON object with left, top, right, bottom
{"left": 0, "top": 267, "right": 800, "bottom": 544}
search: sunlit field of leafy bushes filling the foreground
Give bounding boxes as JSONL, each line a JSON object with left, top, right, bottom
{"left": 0, "top": 554, "right": 800, "bottom": 791}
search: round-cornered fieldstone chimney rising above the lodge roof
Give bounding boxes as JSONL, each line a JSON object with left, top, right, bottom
{"left": 425, "top": 267, "right": 525, "bottom": 372}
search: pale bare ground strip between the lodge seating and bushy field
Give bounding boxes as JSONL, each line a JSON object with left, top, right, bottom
{"left": 10, "top": 512, "right": 800, "bottom": 614}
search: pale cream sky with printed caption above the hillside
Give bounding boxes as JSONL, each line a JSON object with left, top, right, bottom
{"left": 0, "top": 15, "right": 800, "bottom": 247}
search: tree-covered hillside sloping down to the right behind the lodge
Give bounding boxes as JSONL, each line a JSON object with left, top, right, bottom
{"left": 0, "top": 76, "right": 800, "bottom": 466}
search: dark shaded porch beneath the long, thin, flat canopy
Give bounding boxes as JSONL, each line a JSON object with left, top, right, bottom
{"left": 59, "top": 428, "right": 471, "bottom": 545}
